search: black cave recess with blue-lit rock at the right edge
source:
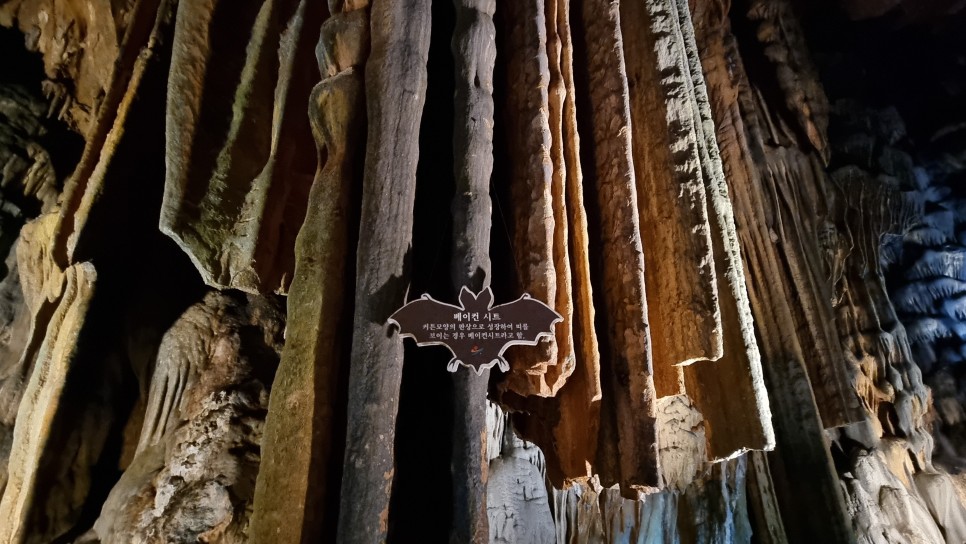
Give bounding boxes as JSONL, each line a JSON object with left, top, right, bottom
{"left": 804, "top": 2, "right": 966, "bottom": 474}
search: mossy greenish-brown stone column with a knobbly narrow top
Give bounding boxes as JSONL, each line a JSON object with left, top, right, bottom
{"left": 249, "top": 2, "right": 369, "bottom": 542}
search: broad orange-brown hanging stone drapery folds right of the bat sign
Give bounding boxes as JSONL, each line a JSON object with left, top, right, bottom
{"left": 503, "top": 2, "right": 773, "bottom": 498}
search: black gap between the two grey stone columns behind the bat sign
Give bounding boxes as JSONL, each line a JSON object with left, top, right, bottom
{"left": 389, "top": 2, "right": 455, "bottom": 543}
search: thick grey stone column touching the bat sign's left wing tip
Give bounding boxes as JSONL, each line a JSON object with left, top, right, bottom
{"left": 338, "top": 0, "right": 430, "bottom": 543}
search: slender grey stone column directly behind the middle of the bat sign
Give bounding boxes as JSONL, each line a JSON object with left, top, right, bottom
{"left": 450, "top": 0, "right": 496, "bottom": 544}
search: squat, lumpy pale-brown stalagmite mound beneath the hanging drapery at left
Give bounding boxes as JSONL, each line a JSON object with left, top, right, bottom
{"left": 93, "top": 291, "right": 284, "bottom": 544}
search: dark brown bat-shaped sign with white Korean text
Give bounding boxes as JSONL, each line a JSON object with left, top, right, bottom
{"left": 389, "top": 287, "right": 563, "bottom": 374}
